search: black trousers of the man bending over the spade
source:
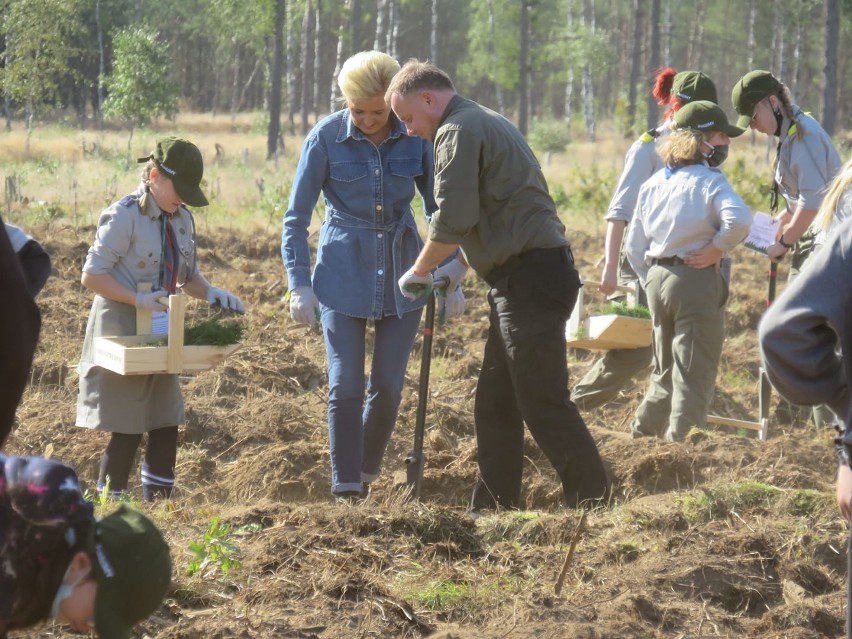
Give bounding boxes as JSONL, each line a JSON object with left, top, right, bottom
{"left": 471, "top": 248, "right": 609, "bottom": 510}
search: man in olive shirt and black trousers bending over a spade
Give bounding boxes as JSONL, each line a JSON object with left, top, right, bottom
{"left": 387, "top": 61, "right": 610, "bottom": 511}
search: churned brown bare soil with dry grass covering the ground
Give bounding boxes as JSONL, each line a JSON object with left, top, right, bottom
{"left": 7, "top": 226, "right": 846, "bottom": 639}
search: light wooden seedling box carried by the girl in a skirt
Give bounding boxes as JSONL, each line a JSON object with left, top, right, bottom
{"left": 94, "top": 294, "right": 242, "bottom": 375}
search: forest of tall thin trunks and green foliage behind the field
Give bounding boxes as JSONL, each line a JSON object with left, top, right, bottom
{"left": 0, "top": 0, "right": 852, "bottom": 158}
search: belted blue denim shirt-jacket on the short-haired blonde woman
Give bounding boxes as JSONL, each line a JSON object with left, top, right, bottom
{"left": 281, "top": 109, "right": 437, "bottom": 319}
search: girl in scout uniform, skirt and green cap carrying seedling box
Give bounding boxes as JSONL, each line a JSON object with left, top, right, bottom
{"left": 76, "top": 137, "right": 245, "bottom": 501}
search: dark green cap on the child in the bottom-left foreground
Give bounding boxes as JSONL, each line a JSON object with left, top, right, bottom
{"left": 87, "top": 505, "right": 172, "bottom": 639}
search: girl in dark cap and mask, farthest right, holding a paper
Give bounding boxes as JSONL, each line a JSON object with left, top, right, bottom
{"left": 731, "top": 70, "right": 841, "bottom": 428}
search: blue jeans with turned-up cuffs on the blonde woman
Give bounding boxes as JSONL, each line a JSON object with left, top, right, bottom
{"left": 322, "top": 306, "right": 421, "bottom": 493}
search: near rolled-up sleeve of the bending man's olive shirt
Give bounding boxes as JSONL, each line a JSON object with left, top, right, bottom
{"left": 429, "top": 128, "right": 481, "bottom": 244}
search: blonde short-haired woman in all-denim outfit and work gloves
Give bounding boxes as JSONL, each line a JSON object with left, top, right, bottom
{"left": 281, "top": 51, "right": 465, "bottom": 501}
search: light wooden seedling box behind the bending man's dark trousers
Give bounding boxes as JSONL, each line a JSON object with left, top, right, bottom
{"left": 565, "top": 282, "right": 652, "bottom": 350}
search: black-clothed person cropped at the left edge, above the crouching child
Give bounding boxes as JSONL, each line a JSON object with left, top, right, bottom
{"left": 0, "top": 215, "right": 41, "bottom": 450}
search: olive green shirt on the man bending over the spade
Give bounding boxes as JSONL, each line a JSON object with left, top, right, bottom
{"left": 429, "top": 95, "right": 570, "bottom": 277}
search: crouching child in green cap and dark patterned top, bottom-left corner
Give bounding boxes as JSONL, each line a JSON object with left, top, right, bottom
{"left": 0, "top": 453, "right": 171, "bottom": 639}
